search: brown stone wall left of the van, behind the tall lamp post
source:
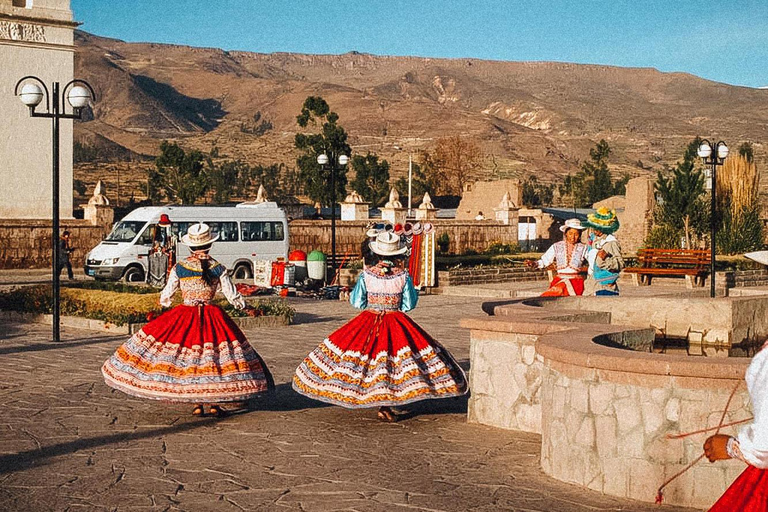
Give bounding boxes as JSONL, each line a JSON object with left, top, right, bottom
{"left": 0, "top": 219, "right": 110, "bottom": 269}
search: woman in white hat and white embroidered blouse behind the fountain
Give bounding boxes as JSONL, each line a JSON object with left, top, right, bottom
{"left": 525, "top": 219, "right": 588, "bottom": 297}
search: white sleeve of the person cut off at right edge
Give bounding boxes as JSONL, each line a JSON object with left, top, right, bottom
{"left": 736, "top": 349, "right": 768, "bottom": 469}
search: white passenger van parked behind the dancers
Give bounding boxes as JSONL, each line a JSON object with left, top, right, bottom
{"left": 85, "top": 202, "right": 288, "bottom": 282}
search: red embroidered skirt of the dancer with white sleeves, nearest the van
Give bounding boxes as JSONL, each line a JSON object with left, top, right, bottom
{"left": 101, "top": 305, "right": 274, "bottom": 403}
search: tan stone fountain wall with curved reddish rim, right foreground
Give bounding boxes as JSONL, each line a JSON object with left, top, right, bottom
{"left": 462, "top": 298, "right": 751, "bottom": 508}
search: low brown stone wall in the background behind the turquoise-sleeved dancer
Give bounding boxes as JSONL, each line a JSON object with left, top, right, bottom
{"left": 289, "top": 219, "right": 517, "bottom": 254}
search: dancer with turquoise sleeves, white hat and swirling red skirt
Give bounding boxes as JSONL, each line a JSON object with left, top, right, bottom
{"left": 293, "top": 231, "right": 467, "bottom": 422}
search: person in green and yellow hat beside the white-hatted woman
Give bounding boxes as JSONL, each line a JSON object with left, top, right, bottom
{"left": 584, "top": 207, "right": 624, "bottom": 297}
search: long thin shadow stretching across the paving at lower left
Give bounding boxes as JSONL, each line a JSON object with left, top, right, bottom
{"left": 0, "top": 417, "right": 218, "bottom": 475}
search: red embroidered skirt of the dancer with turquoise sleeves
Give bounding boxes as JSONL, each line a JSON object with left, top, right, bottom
{"left": 293, "top": 311, "right": 467, "bottom": 408}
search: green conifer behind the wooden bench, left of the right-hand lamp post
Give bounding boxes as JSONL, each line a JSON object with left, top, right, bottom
{"left": 646, "top": 137, "right": 709, "bottom": 248}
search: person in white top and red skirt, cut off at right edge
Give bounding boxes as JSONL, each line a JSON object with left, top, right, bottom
{"left": 704, "top": 343, "right": 768, "bottom": 512}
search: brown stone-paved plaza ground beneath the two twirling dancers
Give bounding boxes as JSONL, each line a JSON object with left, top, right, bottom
{"left": 0, "top": 296, "right": 696, "bottom": 512}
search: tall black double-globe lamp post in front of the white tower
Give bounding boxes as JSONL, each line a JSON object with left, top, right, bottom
{"left": 14, "top": 76, "right": 96, "bottom": 341}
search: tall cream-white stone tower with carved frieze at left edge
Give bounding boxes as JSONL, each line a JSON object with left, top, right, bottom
{"left": 0, "top": 0, "right": 77, "bottom": 219}
